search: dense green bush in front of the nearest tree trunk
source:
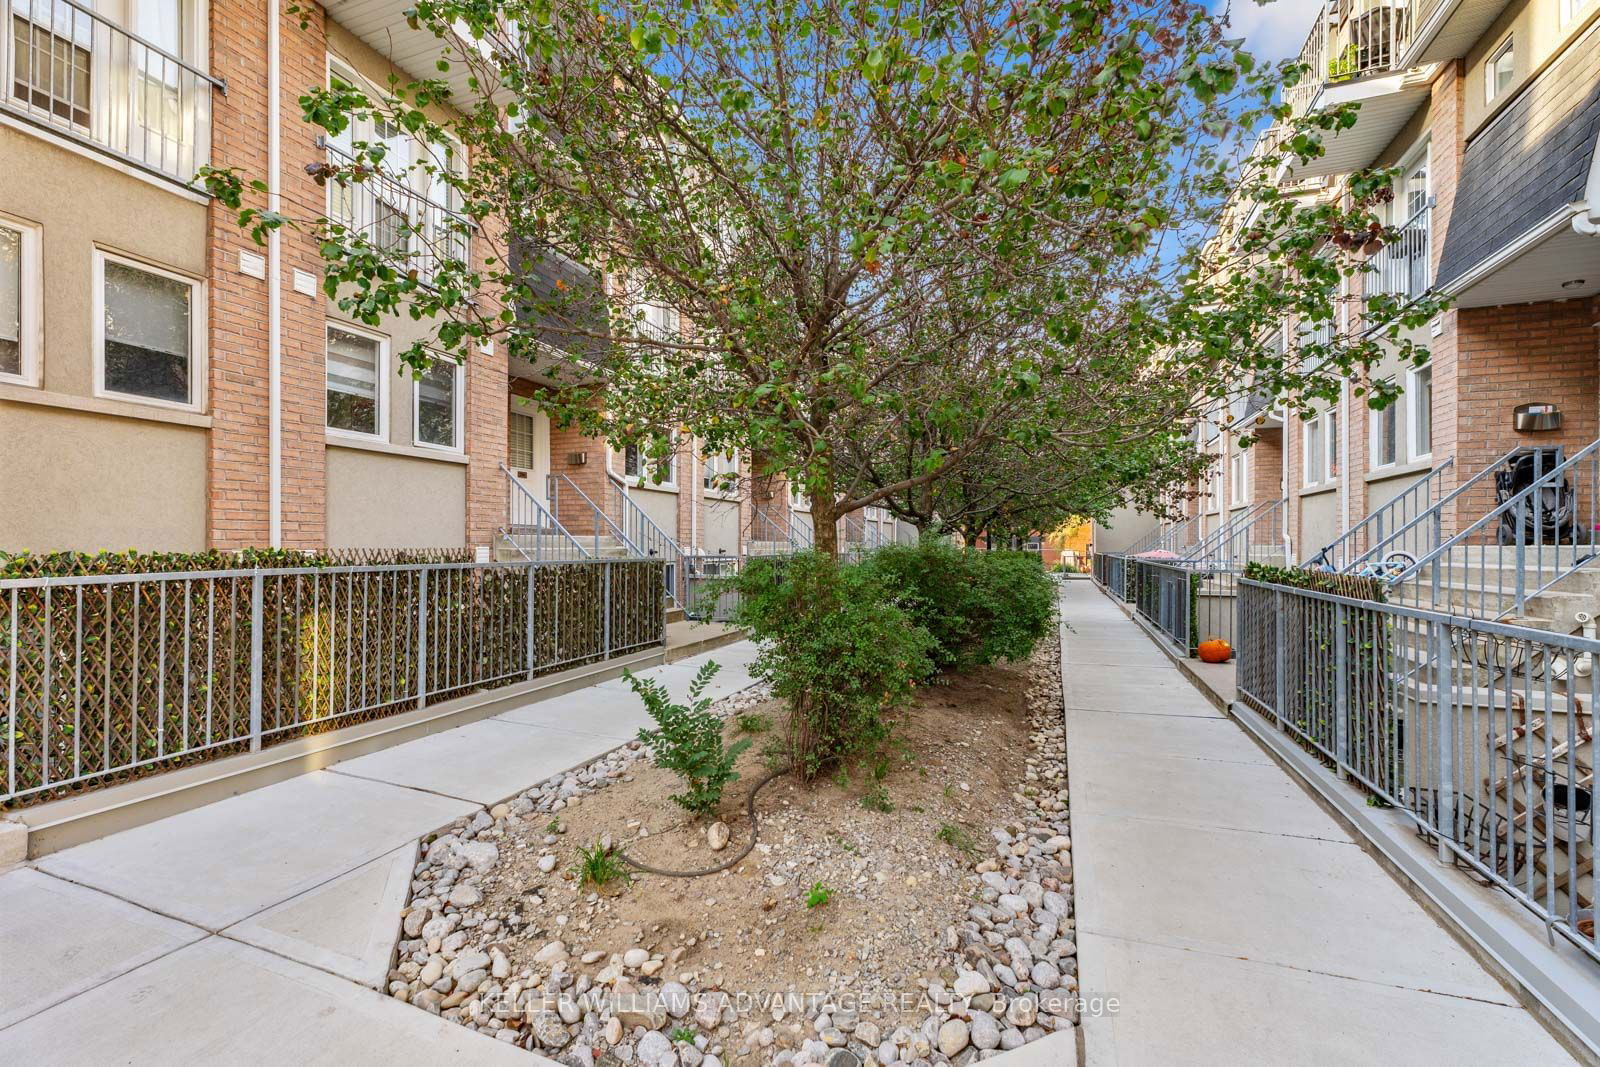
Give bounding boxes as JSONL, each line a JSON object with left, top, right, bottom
{"left": 733, "top": 552, "right": 934, "bottom": 781}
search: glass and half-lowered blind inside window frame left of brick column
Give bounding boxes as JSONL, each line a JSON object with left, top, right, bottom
{"left": 104, "top": 261, "right": 192, "bottom": 403}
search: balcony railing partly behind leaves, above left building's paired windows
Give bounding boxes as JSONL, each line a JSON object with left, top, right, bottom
{"left": 323, "top": 141, "right": 472, "bottom": 292}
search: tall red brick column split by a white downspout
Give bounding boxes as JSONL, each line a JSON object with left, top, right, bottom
{"left": 208, "top": 0, "right": 326, "bottom": 549}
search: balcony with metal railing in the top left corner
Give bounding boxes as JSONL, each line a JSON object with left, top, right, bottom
{"left": 0, "top": 0, "right": 226, "bottom": 186}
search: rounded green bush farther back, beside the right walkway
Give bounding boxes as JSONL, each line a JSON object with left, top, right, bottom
{"left": 864, "top": 537, "right": 1056, "bottom": 669}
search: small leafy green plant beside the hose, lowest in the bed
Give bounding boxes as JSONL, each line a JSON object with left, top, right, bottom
{"left": 622, "top": 662, "right": 750, "bottom": 816}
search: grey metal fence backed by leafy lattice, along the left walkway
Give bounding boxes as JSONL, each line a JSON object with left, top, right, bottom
{"left": 0, "top": 560, "right": 664, "bottom": 806}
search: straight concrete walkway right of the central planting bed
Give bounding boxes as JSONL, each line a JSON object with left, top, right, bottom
{"left": 1062, "top": 582, "right": 1571, "bottom": 1067}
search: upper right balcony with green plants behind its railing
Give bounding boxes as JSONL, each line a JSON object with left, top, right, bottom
{"left": 1283, "top": 0, "right": 1430, "bottom": 181}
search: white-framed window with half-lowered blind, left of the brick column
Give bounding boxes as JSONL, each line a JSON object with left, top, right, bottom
{"left": 94, "top": 248, "right": 205, "bottom": 411}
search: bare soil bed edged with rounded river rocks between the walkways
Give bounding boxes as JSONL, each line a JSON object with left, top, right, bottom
{"left": 387, "top": 638, "right": 1077, "bottom": 1067}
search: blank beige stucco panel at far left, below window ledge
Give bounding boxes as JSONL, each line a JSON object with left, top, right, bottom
{"left": 0, "top": 402, "right": 206, "bottom": 552}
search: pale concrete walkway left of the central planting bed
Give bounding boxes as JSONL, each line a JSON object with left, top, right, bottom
{"left": 0, "top": 641, "right": 755, "bottom": 1067}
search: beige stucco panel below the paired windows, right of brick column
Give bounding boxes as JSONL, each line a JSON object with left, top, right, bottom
{"left": 328, "top": 443, "right": 467, "bottom": 549}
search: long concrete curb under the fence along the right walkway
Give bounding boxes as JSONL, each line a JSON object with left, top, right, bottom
{"left": 1094, "top": 590, "right": 1600, "bottom": 1064}
